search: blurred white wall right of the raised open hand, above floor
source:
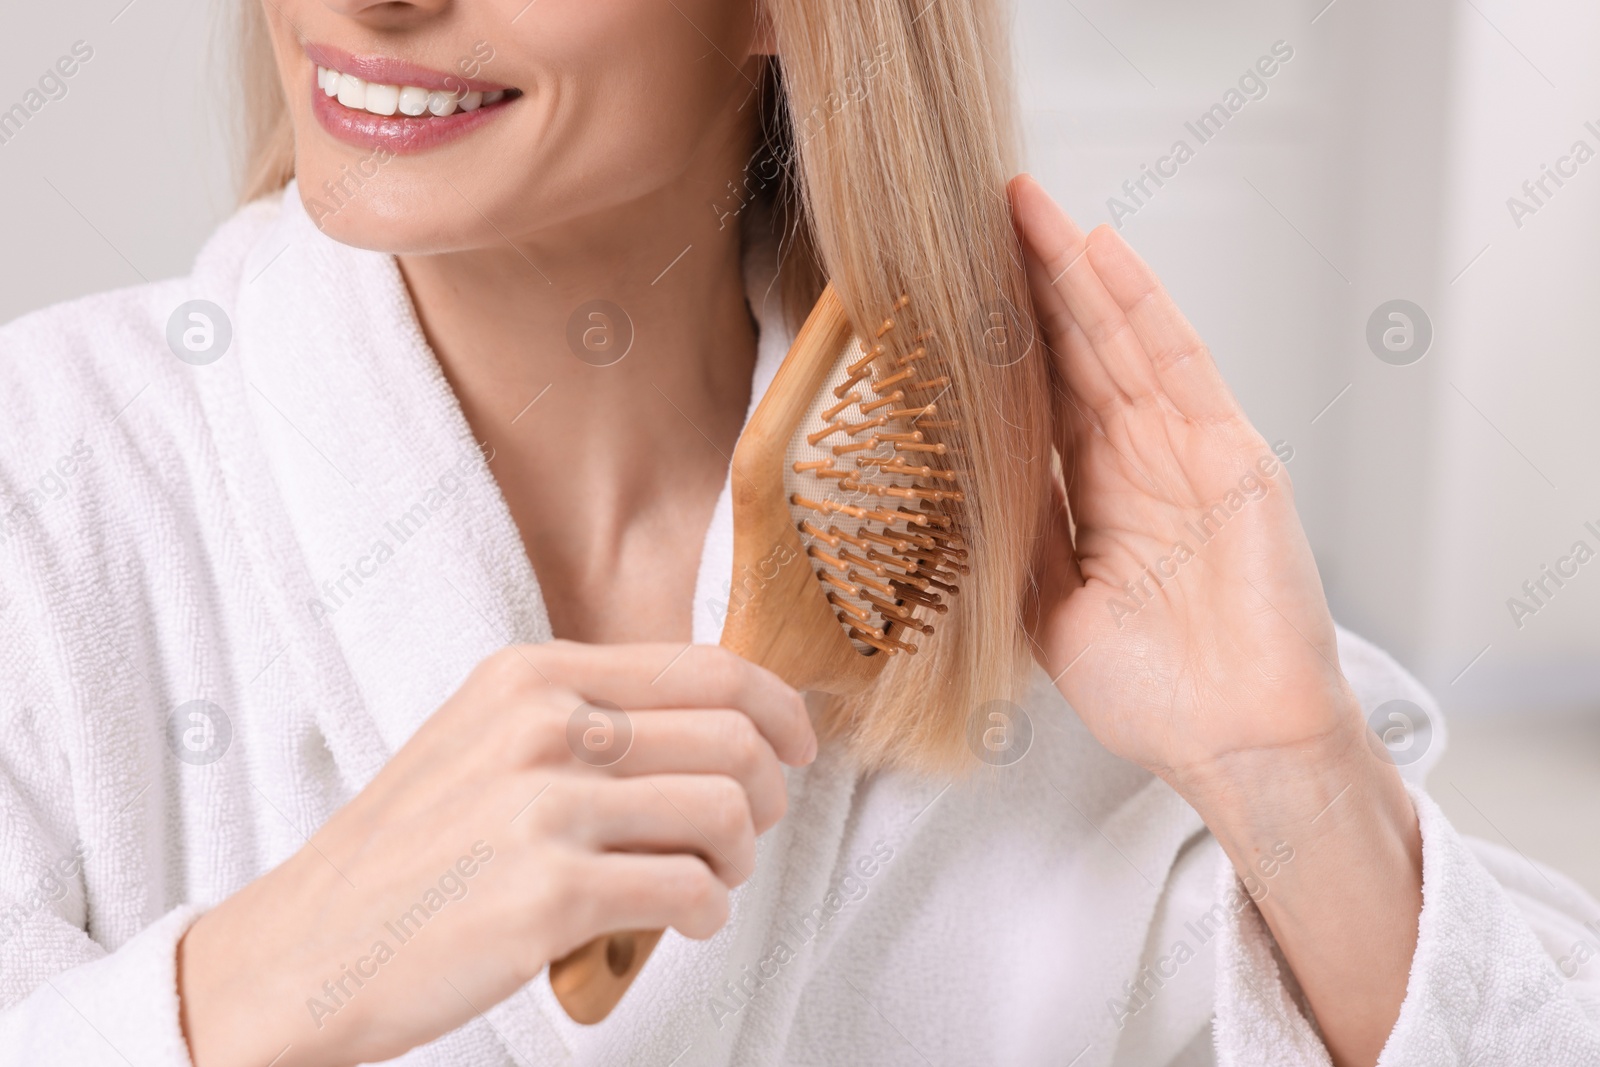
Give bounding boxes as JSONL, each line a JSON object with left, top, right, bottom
{"left": 1018, "top": 0, "right": 1600, "bottom": 712}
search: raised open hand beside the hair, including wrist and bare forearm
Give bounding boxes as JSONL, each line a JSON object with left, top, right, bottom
{"left": 1011, "top": 176, "right": 1421, "bottom": 1064}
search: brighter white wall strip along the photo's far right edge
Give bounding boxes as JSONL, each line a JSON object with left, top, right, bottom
{"left": 1426, "top": 0, "right": 1600, "bottom": 709}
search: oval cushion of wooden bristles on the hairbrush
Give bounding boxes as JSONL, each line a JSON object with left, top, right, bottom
{"left": 786, "top": 296, "right": 968, "bottom": 656}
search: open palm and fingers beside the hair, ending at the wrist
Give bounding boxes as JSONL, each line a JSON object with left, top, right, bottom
{"left": 1013, "top": 179, "right": 1349, "bottom": 774}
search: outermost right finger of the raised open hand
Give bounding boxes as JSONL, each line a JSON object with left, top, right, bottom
{"left": 1088, "top": 226, "right": 1238, "bottom": 419}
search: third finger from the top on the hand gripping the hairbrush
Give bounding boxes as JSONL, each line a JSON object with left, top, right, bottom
{"left": 544, "top": 774, "right": 755, "bottom": 888}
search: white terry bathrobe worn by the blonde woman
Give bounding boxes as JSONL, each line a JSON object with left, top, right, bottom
{"left": 0, "top": 192, "right": 1600, "bottom": 1067}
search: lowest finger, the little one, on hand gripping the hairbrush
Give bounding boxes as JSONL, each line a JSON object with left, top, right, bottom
{"left": 565, "top": 853, "right": 728, "bottom": 950}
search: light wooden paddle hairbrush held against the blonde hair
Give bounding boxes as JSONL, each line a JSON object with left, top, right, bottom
{"left": 550, "top": 285, "right": 968, "bottom": 1024}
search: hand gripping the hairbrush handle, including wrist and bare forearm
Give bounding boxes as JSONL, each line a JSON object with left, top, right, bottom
{"left": 178, "top": 641, "right": 816, "bottom": 1067}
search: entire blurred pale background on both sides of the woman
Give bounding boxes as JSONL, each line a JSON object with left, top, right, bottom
{"left": 0, "top": 0, "right": 1600, "bottom": 894}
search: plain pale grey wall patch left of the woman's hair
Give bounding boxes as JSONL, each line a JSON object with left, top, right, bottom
{"left": 0, "top": 0, "right": 229, "bottom": 322}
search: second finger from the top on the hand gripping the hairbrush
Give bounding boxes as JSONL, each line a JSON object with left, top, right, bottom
{"left": 605, "top": 709, "right": 789, "bottom": 833}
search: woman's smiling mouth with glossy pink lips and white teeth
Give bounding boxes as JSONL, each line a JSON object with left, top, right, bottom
{"left": 306, "top": 45, "right": 522, "bottom": 154}
